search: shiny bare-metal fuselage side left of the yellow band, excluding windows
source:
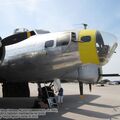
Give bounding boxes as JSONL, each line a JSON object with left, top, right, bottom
{"left": 0, "top": 32, "right": 80, "bottom": 82}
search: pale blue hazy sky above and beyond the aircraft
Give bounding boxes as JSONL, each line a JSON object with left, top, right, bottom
{"left": 0, "top": 0, "right": 120, "bottom": 80}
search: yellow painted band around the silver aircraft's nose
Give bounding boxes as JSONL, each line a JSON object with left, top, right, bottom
{"left": 78, "top": 30, "right": 100, "bottom": 64}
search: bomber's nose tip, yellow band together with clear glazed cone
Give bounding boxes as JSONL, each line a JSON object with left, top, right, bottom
{"left": 78, "top": 29, "right": 117, "bottom": 66}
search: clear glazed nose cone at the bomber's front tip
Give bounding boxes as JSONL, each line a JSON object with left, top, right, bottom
{"left": 96, "top": 31, "right": 117, "bottom": 65}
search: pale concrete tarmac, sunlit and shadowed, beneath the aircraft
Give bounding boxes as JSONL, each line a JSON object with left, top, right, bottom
{"left": 0, "top": 83, "right": 120, "bottom": 120}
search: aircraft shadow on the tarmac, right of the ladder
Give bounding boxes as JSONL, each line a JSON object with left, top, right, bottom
{"left": 40, "top": 95, "right": 120, "bottom": 120}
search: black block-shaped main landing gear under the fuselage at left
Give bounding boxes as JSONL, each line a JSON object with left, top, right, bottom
{"left": 2, "top": 82, "right": 30, "bottom": 97}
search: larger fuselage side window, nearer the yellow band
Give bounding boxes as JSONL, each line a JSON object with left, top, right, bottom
{"left": 56, "top": 33, "right": 70, "bottom": 46}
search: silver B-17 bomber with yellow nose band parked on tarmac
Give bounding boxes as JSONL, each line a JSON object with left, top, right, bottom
{"left": 0, "top": 29, "right": 117, "bottom": 97}
